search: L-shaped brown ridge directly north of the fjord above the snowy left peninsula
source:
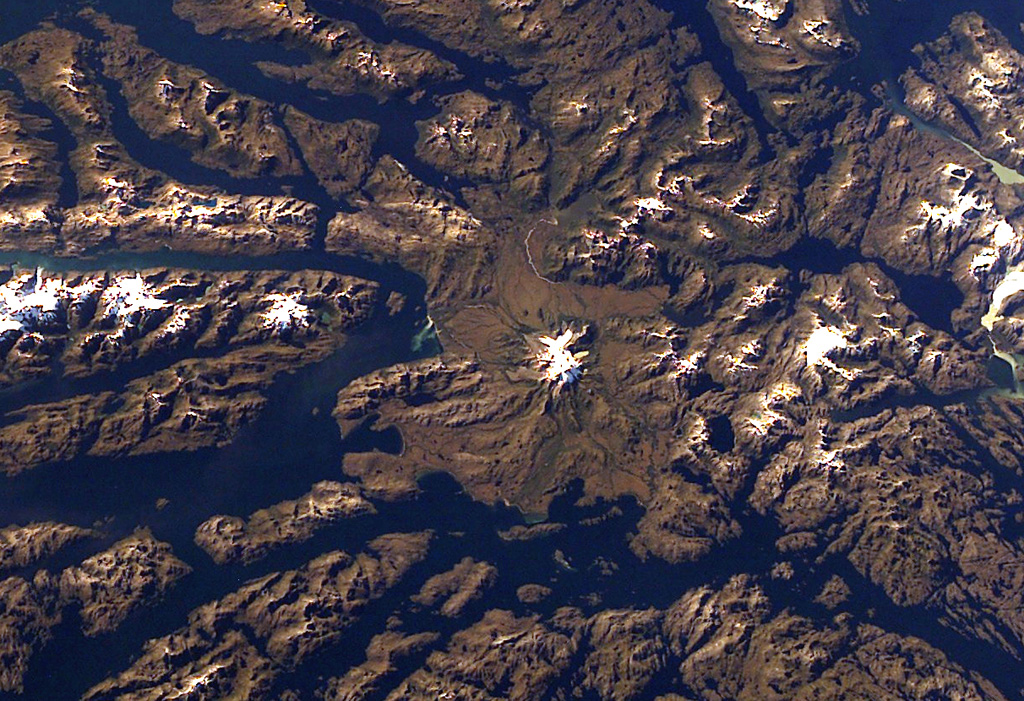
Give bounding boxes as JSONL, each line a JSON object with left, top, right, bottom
{"left": 0, "top": 27, "right": 318, "bottom": 255}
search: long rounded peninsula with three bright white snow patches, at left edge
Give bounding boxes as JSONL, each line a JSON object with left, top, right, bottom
{"left": 0, "top": 267, "right": 380, "bottom": 388}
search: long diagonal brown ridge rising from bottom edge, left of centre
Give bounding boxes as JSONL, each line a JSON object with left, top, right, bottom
{"left": 85, "top": 533, "right": 430, "bottom": 701}
